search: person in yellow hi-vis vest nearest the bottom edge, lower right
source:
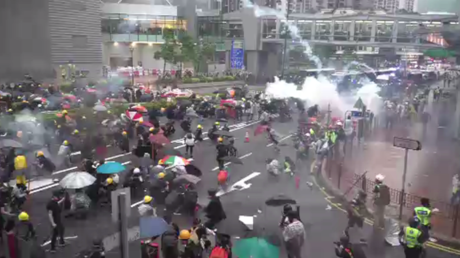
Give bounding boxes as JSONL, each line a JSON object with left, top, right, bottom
{"left": 399, "top": 219, "right": 424, "bottom": 258}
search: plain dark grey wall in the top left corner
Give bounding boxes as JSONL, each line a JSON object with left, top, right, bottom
{"left": 0, "top": 0, "right": 53, "bottom": 82}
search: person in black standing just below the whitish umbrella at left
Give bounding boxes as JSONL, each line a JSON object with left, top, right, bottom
{"left": 46, "top": 191, "right": 65, "bottom": 253}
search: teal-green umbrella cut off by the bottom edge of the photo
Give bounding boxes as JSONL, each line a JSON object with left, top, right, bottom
{"left": 232, "top": 237, "right": 280, "bottom": 258}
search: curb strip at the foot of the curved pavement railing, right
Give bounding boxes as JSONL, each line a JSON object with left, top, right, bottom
{"left": 316, "top": 155, "right": 460, "bottom": 255}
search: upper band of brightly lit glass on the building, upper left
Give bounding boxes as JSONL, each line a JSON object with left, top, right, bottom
{"left": 101, "top": 14, "right": 187, "bottom": 43}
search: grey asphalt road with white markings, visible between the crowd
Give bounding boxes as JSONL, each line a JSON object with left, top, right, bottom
{"left": 18, "top": 112, "right": 457, "bottom": 258}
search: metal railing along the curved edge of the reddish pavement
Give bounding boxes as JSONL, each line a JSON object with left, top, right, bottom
{"left": 324, "top": 152, "right": 460, "bottom": 239}
